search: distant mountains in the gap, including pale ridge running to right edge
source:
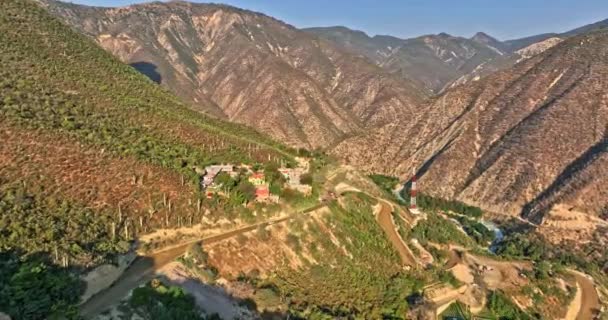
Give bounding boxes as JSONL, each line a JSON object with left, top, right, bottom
{"left": 305, "top": 20, "right": 608, "bottom": 94}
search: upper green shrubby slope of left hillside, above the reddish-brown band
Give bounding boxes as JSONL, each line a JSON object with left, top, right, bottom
{"left": 0, "top": 1, "right": 294, "bottom": 176}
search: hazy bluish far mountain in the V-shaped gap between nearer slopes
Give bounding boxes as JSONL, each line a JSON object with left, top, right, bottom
{"left": 305, "top": 27, "right": 511, "bottom": 93}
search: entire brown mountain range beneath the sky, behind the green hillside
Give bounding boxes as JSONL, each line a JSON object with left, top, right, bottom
{"left": 40, "top": 0, "right": 608, "bottom": 222}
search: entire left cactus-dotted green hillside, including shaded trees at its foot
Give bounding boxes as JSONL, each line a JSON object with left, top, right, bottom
{"left": 0, "top": 0, "right": 293, "bottom": 319}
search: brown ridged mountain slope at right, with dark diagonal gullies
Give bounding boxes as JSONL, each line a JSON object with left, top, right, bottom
{"left": 334, "top": 31, "right": 608, "bottom": 222}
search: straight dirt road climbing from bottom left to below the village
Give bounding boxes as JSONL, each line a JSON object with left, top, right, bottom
{"left": 80, "top": 205, "right": 324, "bottom": 319}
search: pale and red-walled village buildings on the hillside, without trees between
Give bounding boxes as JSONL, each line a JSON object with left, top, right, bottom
{"left": 195, "top": 158, "right": 312, "bottom": 203}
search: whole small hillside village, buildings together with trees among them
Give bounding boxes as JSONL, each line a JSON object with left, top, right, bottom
{"left": 195, "top": 157, "right": 312, "bottom": 203}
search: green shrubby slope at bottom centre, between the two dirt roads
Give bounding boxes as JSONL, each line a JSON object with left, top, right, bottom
{"left": 274, "top": 194, "right": 430, "bottom": 319}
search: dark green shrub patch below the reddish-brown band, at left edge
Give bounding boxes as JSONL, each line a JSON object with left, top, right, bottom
{"left": 0, "top": 185, "right": 129, "bottom": 266}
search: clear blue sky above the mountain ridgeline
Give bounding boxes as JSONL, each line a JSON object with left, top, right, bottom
{"left": 64, "top": 0, "right": 608, "bottom": 40}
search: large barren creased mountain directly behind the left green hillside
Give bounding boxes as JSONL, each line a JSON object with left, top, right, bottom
{"left": 43, "top": 1, "right": 425, "bottom": 148}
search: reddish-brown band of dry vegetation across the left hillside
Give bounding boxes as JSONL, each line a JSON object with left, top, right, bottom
{"left": 0, "top": 123, "right": 195, "bottom": 213}
